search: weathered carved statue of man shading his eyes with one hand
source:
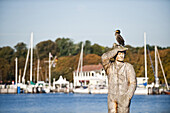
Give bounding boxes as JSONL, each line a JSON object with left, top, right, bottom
{"left": 102, "top": 46, "right": 136, "bottom": 113}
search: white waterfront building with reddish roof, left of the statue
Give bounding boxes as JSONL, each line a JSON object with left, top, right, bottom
{"left": 73, "top": 64, "right": 108, "bottom": 88}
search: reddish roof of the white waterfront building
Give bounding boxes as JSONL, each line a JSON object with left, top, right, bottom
{"left": 74, "top": 64, "right": 103, "bottom": 72}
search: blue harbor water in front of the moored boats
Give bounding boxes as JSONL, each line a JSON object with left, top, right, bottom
{"left": 0, "top": 93, "right": 170, "bottom": 113}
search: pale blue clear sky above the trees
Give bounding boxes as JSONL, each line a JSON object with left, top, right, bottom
{"left": 0, "top": 0, "right": 170, "bottom": 47}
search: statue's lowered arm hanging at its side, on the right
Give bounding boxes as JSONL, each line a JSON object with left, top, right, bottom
{"left": 127, "top": 64, "right": 136, "bottom": 99}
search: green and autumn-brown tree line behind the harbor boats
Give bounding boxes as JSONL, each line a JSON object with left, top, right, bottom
{"left": 0, "top": 38, "right": 170, "bottom": 84}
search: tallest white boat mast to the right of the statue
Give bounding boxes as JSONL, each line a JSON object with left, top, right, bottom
{"left": 144, "top": 32, "right": 148, "bottom": 83}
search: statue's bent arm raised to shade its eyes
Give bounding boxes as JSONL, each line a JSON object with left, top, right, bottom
{"left": 101, "top": 50, "right": 116, "bottom": 75}
